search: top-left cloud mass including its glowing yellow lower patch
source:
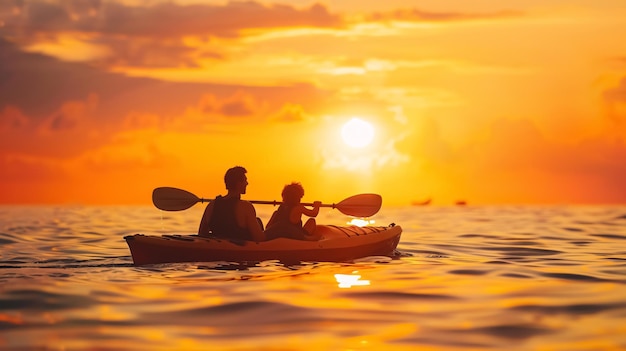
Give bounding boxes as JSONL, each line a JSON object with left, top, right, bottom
{"left": 0, "top": 0, "right": 342, "bottom": 68}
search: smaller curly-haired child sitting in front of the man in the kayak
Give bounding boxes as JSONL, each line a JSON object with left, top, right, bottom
{"left": 265, "top": 183, "right": 322, "bottom": 240}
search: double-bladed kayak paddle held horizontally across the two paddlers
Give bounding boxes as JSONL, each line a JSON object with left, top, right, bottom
{"left": 152, "top": 187, "right": 383, "bottom": 217}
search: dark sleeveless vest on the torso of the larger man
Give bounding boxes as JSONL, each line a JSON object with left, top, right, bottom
{"left": 209, "top": 195, "right": 252, "bottom": 240}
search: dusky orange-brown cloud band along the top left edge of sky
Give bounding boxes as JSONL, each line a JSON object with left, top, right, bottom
{"left": 0, "top": 1, "right": 341, "bottom": 39}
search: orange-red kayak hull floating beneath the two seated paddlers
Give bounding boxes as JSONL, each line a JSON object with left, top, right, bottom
{"left": 124, "top": 225, "right": 402, "bottom": 265}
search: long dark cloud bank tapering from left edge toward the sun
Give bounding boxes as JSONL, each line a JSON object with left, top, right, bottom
{"left": 0, "top": 39, "right": 323, "bottom": 132}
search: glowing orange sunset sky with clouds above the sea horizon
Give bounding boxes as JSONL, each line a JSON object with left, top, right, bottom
{"left": 0, "top": 0, "right": 626, "bottom": 205}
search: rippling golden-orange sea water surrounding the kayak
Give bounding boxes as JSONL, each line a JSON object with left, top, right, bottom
{"left": 0, "top": 205, "right": 626, "bottom": 351}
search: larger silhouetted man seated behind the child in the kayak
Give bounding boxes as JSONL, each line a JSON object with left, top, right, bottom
{"left": 198, "top": 166, "right": 266, "bottom": 241}
